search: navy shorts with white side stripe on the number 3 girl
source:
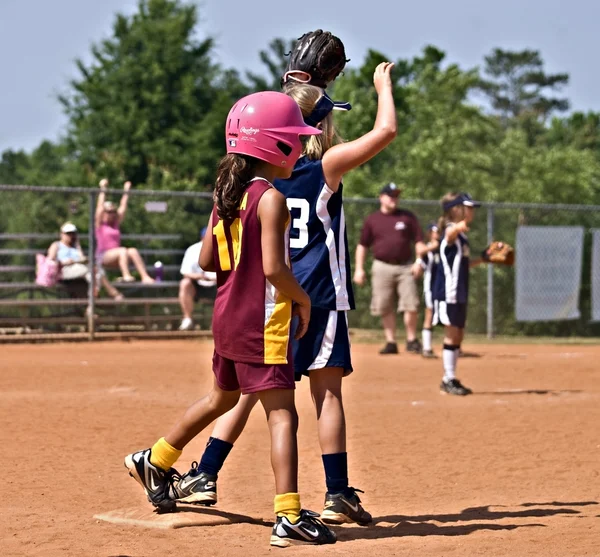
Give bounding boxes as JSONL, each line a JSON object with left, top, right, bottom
{"left": 292, "top": 308, "right": 352, "bottom": 381}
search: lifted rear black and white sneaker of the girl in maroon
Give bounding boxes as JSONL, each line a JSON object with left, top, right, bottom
{"left": 125, "top": 449, "right": 181, "bottom": 512}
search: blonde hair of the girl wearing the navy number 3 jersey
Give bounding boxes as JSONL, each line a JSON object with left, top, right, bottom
{"left": 284, "top": 81, "right": 341, "bottom": 160}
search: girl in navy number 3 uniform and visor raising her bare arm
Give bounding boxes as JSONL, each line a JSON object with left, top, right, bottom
{"left": 180, "top": 63, "right": 396, "bottom": 524}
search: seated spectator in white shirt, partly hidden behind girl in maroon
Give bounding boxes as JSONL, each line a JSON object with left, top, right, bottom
{"left": 179, "top": 228, "right": 217, "bottom": 331}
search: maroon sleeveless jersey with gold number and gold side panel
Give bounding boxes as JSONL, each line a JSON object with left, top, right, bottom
{"left": 212, "top": 179, "right": 292, "bottom": 364}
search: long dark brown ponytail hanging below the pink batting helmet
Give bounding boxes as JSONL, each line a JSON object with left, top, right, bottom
{"left": 213, "top": 153, "right": 258, "bottom": 220}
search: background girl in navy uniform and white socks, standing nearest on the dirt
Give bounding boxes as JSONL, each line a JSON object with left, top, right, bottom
{"left": 433, "top": 193, "right": 481, "bottom": 396}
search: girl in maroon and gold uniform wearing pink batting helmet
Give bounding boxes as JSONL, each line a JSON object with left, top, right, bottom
{"left": 125, "top": 92, "right": 336, "bottom": 547}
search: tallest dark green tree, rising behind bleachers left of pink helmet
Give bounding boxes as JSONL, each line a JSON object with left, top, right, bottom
{"left": 60, "top": 0, "right": 246, "bottom": 188}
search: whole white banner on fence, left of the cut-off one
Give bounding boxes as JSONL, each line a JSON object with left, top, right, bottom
{"left": 515, "top": 226, "right": 584, "bottom": 321}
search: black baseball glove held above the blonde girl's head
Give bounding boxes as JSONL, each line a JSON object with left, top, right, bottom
{"left": 281, "top": 29, "right": 350, "bottom": 89}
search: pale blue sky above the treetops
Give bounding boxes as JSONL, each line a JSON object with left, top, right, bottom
{"left": 0, "top": 0, "right": 600, "bottom": 152}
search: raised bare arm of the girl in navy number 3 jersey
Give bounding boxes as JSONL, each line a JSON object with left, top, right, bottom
{"left": 323, "top": 62, "right": 397, "bottom": 191}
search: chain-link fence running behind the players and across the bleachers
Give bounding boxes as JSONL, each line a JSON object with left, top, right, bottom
{"left": 0, "top": 186, "right": 600, "bottom": 336}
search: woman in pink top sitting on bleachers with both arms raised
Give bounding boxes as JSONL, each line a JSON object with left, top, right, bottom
{"left": 96, "top": 179, "right": 154, "bottom": 283}
